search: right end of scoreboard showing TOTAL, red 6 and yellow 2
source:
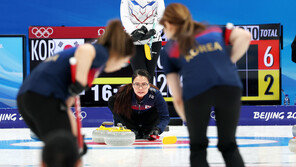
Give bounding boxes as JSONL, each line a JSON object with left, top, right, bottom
{"left": 236, "top": 24, "right": 282, "bottom": 104}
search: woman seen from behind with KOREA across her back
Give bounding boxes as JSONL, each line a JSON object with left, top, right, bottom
{"left": 160, "top": 3, "right": 251, "bottom": 167}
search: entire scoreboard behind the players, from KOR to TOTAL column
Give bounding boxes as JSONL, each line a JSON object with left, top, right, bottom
{"left": 28, "top": 24, "right": 282, "bottom": 107}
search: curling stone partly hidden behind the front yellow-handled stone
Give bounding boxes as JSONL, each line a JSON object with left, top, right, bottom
{"left": 92, "top": 122, "right": 114, "bottom": 143}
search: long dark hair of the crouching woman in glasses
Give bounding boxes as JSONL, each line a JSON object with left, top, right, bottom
{"left": 114, "top": 69, "right": 158, "bottom": 119}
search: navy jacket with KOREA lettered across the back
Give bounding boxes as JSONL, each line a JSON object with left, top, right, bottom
{"left": 160, "top": 27, "right": 242, "bottom": 100}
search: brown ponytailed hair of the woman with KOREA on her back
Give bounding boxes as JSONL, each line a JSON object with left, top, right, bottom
{"left": 159, "top": 3, "right": 206, "bottom": 55}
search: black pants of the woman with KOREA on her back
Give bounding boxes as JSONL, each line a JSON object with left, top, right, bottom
{"left": 184, "top": 86, "right": 244, "bottom": 167}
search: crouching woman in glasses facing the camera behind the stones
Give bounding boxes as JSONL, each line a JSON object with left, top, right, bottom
{"left": 108, "top": 69, "right": 170, "bottom": 140}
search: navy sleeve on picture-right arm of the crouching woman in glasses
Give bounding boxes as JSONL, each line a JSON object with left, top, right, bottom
{"left": 155, "top": 91, "right": 170, "bottom": 133}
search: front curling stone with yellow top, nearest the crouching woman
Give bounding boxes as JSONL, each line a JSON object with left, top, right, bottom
{"left": 105, "top": 123, "right": 136, "bottom": 146}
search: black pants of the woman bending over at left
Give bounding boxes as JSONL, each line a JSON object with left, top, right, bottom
{"left": 17, "top": 91, "right": 72, "bottom": 140}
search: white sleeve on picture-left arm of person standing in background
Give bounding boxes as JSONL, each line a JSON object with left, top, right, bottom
{"left": 120, "top": 0, "right": 136, "bottom": 34}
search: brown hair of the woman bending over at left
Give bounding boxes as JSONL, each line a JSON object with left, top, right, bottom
{"left": 97, "top": 19, "right": 135, "bottom": 57}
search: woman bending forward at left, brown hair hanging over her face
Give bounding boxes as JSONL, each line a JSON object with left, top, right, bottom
{"left": 17, "top": 20, "right": 134, "bottom": 147}
